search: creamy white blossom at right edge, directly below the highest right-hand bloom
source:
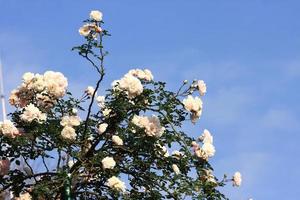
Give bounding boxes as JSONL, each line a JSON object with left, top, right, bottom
{"left": 182, "top": 95, "right": 203, "bottom": 123}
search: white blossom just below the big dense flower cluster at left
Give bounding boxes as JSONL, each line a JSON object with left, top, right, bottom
{"left": 21, "top": 104, "right": 47, "bottom": 123}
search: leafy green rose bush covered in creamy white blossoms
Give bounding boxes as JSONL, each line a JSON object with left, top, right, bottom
{"left": 0, "top": 11, "right": 241, "bottom": 199}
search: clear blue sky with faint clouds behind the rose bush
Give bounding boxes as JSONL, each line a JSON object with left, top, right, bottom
{"left": 0, "top": 0, "right": 300, "bottom": 200}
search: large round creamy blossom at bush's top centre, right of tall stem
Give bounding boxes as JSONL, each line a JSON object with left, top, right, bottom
{"left": 118, "top": 74, "right": 143, "bottom": 99}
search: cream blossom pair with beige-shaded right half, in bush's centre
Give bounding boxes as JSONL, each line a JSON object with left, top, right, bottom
{"left": 132, "top": 115, "right": 165, "bottom": 137}
